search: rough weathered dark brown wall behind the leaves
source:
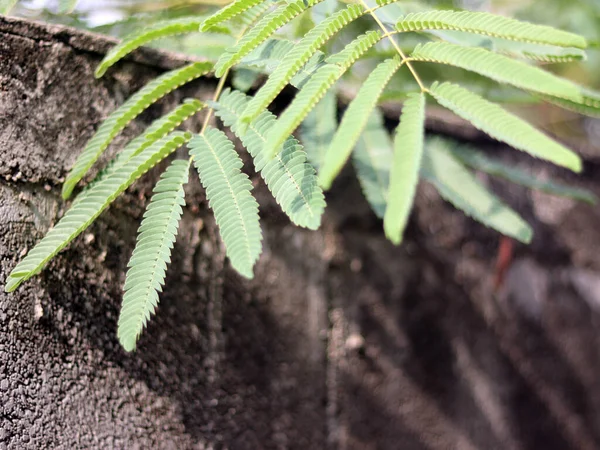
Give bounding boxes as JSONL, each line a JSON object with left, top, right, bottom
{"left": 0, "top": 14, "right": 600, "bottom": 450}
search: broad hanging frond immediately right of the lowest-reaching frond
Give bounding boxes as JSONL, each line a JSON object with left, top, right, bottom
{"left": 188, "top": 127, "right": 262, "bottom": 278}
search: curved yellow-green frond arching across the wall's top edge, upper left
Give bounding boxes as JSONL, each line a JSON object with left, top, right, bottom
{"left": 94, "top": 17, "right": 213, "bottom": 78}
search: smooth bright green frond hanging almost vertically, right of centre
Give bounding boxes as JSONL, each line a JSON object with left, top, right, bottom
{"left": 383, "top": 94, "right": 425, "bottom": 245}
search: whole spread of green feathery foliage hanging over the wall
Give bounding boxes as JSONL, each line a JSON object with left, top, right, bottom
{"left": 2, "top": 0, "right": 600, "bottom": 350}
